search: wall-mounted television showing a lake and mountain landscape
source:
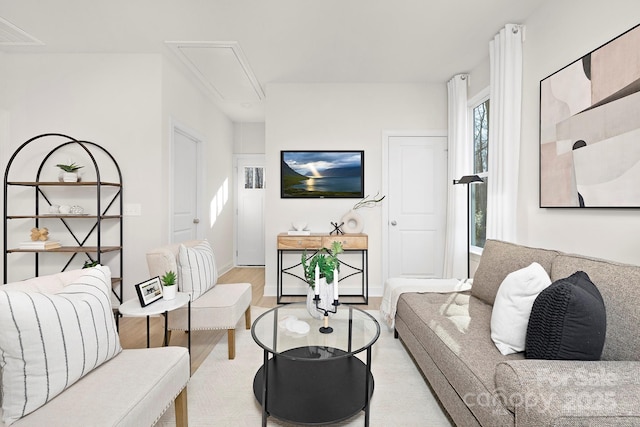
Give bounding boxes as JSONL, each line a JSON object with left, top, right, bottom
{"left": 280, "top": 150, "right": 364, "bottom": 199}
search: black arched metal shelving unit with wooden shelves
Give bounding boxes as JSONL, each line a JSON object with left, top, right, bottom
{"left": 4, "top": 133, "right": 124, "bottom": 305}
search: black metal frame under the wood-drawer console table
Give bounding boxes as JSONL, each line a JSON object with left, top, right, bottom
{"left": 276, "top": 249, "right": 369, "bottom": 304}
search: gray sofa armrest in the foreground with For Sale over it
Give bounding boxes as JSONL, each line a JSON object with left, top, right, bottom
{"left": 495, "top": 360, "right": 640, "bottom": 426}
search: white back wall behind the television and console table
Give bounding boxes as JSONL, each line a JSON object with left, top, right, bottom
{"left": 265, "top": 83, "right": 447, "bottom": 295}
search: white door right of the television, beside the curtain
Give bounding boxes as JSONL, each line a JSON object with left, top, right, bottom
{"left": 387, "top": 136, "right": 447, "bottom": 277}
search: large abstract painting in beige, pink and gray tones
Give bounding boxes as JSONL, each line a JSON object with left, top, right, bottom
{"left": 540, "top": 26, "right": 640, "bottom": 208}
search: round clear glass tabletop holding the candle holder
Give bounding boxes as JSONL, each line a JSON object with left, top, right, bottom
{"left": 251, "top": 303, "right": 380, "bottom": 360}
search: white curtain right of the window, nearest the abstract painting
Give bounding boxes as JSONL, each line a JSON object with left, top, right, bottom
{"left": 487, "top": 24, "right": 524, "bottom": 242}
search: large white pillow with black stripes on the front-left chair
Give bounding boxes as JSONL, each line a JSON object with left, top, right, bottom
{"left": 0, "top": 266, "right": 122, "bottom": 425}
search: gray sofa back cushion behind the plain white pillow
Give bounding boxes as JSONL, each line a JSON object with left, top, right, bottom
{"left": 471, "top": 240, "right": 556, "bottom": 305}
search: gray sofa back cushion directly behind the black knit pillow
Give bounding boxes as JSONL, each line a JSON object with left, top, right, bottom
{"left": 551, "top": 255, "right": 640, "bottom": 361}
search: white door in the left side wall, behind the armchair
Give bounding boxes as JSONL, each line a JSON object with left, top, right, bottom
{"left": 171, "top": 126, "right": 200, "bottom": 243}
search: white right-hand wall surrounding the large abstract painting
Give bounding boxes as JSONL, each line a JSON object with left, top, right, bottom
{"left": 518, "top": 0, "right": 640, "bottom": 264}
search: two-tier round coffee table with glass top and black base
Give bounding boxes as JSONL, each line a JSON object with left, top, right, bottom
{"left": 251, "top": 303, "right": 380, "bottom": 426}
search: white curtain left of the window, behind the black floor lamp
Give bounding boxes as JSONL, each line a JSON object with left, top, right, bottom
{"left": 443, "top": 74, "right": 473, "bottom": 278}
